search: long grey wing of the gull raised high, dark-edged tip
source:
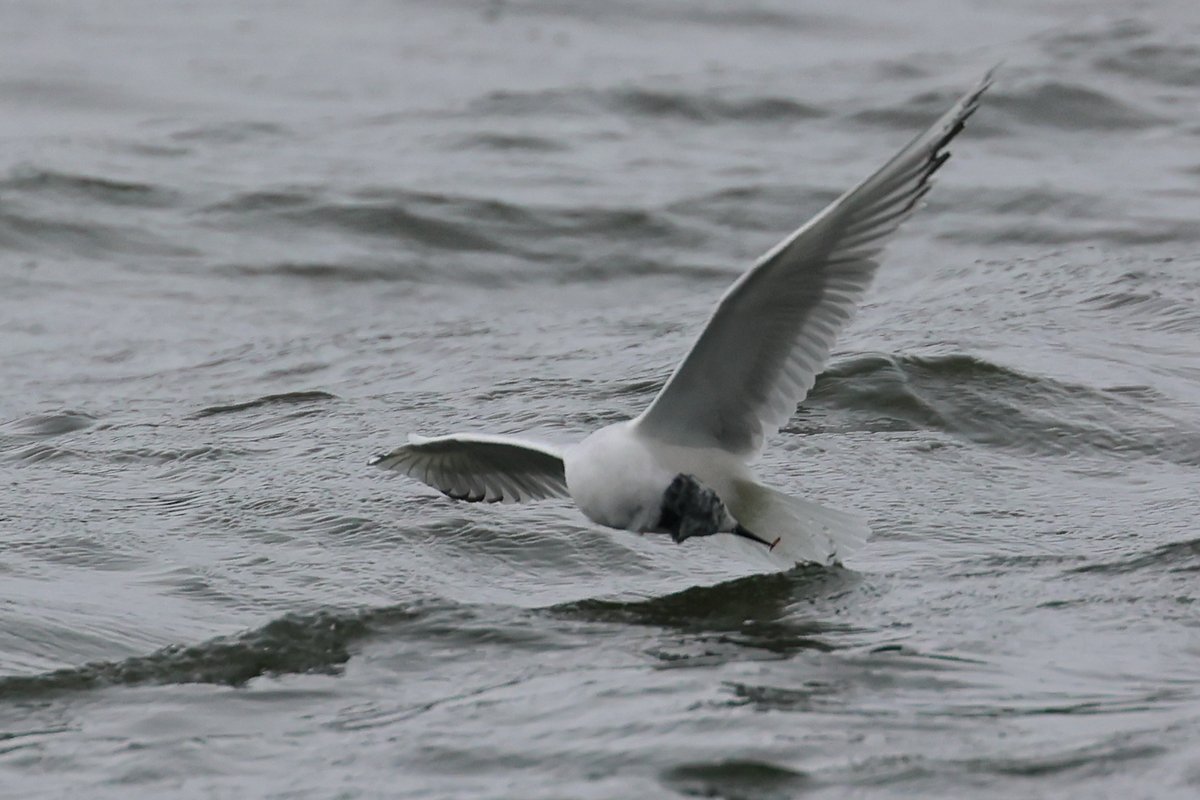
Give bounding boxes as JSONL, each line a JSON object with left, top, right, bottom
{"left": 636, "top": 72, "right": 991, "bottom": 459}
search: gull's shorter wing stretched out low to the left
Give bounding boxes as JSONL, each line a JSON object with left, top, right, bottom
{"left": 368, "top": 434, "right": 569, "bottom": 503}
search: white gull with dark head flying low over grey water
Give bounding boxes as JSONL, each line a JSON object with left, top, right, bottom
{"left": 368, "top": 68, "right": 995, "bottom": 567}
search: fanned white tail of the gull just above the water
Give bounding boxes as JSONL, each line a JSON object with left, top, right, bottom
{"left": 728, "top": 481, "right": 871, "bottom": 565}
